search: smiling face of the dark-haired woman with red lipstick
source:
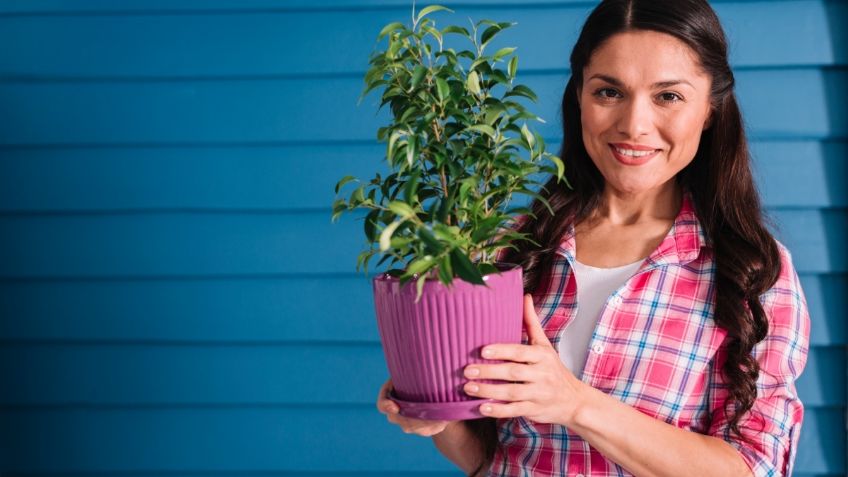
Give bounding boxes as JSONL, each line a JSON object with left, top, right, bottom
{"left": 577, "top": 30, "right": 711, "bottom": 195}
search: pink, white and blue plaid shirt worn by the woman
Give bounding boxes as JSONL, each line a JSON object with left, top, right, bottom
{"left": 487, "top": 191, "right": 810, "bottom": 477}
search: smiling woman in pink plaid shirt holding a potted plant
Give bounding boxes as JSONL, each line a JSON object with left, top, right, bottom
{"left": 377, "top": 0, "right": 810, "bottom": 477}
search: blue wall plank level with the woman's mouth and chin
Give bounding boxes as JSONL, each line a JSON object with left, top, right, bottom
{"left": 0, "top": 141, "right": 848, "bottom": 212}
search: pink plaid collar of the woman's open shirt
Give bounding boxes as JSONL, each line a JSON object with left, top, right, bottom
{"left": 556, "top": 190, "right": 710, "bottom": 267}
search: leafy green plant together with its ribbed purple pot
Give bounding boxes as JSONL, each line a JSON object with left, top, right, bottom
{"left": 332, "top": 5, "right": 570, "bottom": 419}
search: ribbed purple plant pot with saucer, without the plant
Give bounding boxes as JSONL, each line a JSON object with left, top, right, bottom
{"left": 373, "top": 263, "right": 524, "bottom": 420}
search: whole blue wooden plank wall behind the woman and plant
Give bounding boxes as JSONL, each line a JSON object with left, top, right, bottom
{"left": 0, "top": 0, "right": 848, "bottom": 477}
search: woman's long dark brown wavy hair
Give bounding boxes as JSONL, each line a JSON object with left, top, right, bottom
{"left": 468, "top": 0, "right": 780, "bottom": 475}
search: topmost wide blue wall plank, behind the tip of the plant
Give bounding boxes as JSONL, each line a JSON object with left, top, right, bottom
{"left": 0, "top": 1, "right": 848, "bottom": 78}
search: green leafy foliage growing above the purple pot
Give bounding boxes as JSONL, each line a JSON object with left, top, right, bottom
{"left": 332, "top": 5, "right": 570, "bottom": 296}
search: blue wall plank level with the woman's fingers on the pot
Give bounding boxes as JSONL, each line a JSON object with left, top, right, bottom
{"left": 0, "top": 343, "right": 846, "bottom": 408}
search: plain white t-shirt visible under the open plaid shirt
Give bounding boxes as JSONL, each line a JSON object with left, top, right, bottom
{"left": 559, "top": 258, "right": 645, "bottom": 379}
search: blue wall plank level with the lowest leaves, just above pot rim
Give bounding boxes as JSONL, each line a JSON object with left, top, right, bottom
{"left": 0, "top": 209, "right": 848, "bottom": 280}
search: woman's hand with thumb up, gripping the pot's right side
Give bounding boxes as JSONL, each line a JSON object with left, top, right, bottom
{"left": 464, "top": 294, "right": 585, "bottom": 426}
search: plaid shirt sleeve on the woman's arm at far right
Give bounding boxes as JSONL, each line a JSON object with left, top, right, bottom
{"left": 708, "top": 242, "right": 810, "bottom": 477}
